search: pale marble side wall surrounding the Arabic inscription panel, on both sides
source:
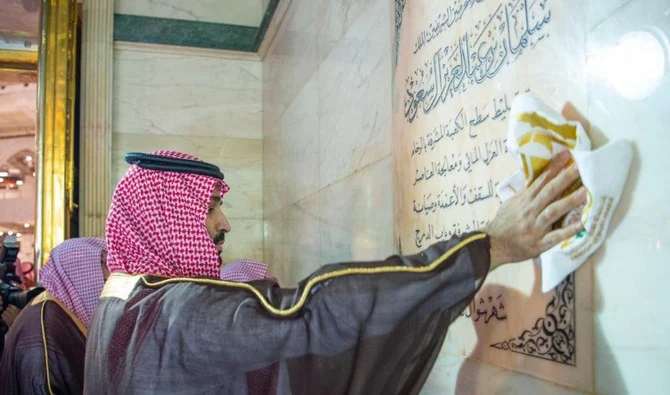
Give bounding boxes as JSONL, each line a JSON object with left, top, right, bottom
{"left": 263, "top": 0, "right": 670, "bottom": 395}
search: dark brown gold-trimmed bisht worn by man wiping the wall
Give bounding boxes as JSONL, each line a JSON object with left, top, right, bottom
{"left": 85, "top": 233, "right": 490, "bottom": 395}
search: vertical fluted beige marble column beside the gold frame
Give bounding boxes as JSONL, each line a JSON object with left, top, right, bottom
{"left": 79, "top": 0, "right": 114, "bottom": 237}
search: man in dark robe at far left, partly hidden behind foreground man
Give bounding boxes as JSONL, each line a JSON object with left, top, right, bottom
{"left": 0, "top": 238, "right": 109, "bottom": 394}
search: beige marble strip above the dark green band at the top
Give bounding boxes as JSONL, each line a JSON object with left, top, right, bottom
{"left": 114, "top": 0, "right": 267, "bottom": 26}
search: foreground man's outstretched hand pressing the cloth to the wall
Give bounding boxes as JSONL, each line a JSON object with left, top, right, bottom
{"left": 485, "top": 151, "right": 586, "bottom": 270}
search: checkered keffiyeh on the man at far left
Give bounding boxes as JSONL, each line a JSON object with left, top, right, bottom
{"left": 40, "top": 237, "right": 105, "bottom": 328}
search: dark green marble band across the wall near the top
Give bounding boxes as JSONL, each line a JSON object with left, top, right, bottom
{"left": 114, "top": 0, "right": 280, "bottom": 52}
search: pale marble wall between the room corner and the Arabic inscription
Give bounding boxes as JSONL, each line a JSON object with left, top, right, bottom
{"left": 263, "top": 0, "right": 394, "bottom": 285}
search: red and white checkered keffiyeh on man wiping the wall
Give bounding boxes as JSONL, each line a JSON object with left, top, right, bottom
{"left": 106, "top": 151, "right": 230, "bottom": 278}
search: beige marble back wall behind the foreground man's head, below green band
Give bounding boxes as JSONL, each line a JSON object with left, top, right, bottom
{"left": 112, "top": 43, "right": 263, "bottom": 263}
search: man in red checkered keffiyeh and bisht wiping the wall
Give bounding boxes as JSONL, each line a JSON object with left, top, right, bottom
{"left": 85, "top": 151, "right": 585, "bottom": 395}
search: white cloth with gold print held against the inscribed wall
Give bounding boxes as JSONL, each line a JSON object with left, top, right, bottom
{"left": 498, "top": 94, "right": 633, "bottom": 292}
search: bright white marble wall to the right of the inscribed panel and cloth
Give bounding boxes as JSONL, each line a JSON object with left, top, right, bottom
{"left": 588, "top": 0, "right": 670, "bottom": 394}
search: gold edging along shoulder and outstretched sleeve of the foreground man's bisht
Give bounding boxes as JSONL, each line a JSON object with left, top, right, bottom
{"left": 142, "top": 233, "right": 487, "bottom": 317}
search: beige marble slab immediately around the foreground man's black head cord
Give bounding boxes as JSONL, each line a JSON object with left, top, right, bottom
{"left": 112, "top": 134, "right": 263, "bottom": 219}
